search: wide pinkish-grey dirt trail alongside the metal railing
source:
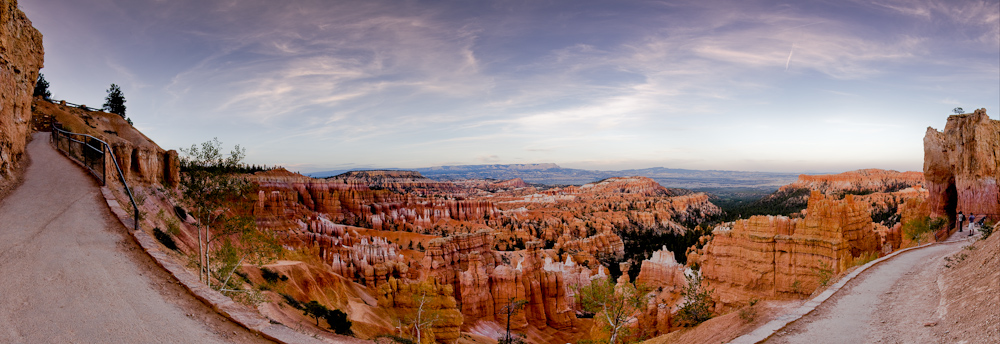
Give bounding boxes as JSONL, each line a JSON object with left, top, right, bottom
{"left": 0, "top": 133, "right": 266, "bottom": 343}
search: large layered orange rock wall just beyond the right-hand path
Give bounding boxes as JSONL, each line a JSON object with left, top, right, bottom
{"left": 691, "top": 191, "right": 879, "bottom": 305}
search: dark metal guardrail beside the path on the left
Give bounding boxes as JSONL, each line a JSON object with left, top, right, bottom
{"left": 49, "top": 123, "right": 139, "bottom": 230}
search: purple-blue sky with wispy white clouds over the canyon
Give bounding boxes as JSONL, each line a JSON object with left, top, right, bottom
{"left": 18, "top": 0, "right": 1000, "bottom": 173}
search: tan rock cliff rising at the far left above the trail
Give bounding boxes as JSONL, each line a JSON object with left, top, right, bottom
{"left": 0, "top": 0, "right": 44, "bottom": 186}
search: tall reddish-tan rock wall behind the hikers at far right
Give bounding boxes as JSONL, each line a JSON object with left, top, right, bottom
{"left": 924, "top": 109, "right": 1000, "bottom": 227}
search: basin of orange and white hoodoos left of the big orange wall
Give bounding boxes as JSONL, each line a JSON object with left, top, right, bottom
{"left": 250, "top": 169, "right": 720, "bottom": 342}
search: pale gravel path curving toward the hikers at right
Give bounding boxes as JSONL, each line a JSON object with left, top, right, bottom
{"left": 767, "top": 233, "right": 968, "bottom": 344}
